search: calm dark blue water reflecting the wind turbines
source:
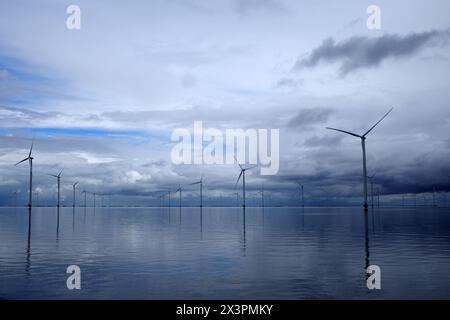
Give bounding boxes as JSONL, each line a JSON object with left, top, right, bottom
{"left": 0, "top": 208, "right": 450, "bottom": 299}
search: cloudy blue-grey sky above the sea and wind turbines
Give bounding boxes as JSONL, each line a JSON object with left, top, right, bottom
{"left": 0, "top": 0, "right": 450, "bottom": 205}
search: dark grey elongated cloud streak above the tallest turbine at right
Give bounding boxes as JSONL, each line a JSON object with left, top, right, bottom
{"left": 294, "top": 29, "right": 450, "bottom": 76}
